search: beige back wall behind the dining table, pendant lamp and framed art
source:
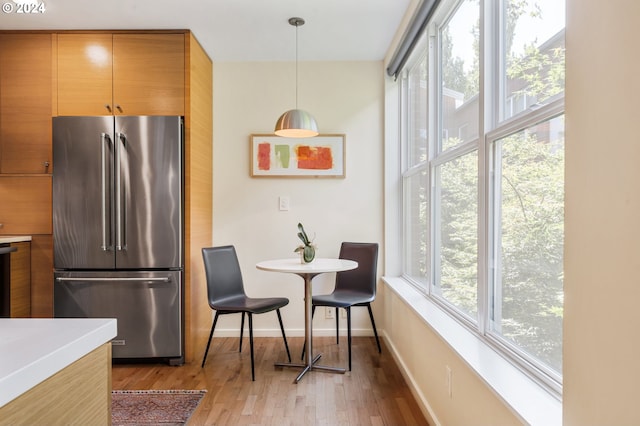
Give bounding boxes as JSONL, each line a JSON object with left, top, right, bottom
{"left": 213, "top": 62, "right": 383, "bottom": 336}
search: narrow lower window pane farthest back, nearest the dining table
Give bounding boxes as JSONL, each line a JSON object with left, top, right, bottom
{"left": 404, "top": 168, "right": 429, "bottom": 287}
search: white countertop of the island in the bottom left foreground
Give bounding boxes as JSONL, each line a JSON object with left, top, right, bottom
{"left": 0, "top": 318, "right": 117, "bottom": 407}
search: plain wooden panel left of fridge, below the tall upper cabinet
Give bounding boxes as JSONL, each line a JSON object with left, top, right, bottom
{"left": 0, "top": 175, "right": 52, "bottom": 235}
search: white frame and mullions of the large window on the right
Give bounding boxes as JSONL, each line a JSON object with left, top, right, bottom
{"left": 398, "top": 0, "right": 564, "bottom": 399}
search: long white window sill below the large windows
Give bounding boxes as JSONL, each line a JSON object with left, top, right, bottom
{"left": 383, "top": 277, "right": 562, "bottom": 425}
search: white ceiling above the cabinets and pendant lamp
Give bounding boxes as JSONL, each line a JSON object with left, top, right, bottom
{"left": 0, "top": 0, "right": 415, "bottom": 62}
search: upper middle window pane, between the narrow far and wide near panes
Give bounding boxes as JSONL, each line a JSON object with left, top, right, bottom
{"left": 440, "top": 0, "right": 480, "bottom": 151}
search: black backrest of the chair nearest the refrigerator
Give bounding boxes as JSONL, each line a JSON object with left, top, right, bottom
{"left": 202, "top": 246, "right": 246, "bottom": 307}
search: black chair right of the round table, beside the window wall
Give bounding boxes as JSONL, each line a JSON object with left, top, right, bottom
{"left": 302, "top": 242, "right": 382, "bottom": 370}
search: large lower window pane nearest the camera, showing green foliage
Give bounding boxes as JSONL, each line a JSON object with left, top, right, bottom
{"left": 490, "top": 116, "right": 564, "bottom": 372}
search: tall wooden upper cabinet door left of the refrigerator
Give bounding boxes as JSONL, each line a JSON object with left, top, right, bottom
{"left": 0, "top": 34, "right": 52, "bottom": 173}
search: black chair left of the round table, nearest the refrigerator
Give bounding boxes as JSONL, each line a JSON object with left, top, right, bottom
{"left": 202, "top": 246, "right": 291, "bottom": 380}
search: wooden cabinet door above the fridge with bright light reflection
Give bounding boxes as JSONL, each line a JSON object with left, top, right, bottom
{"left": 58, "top": 34, "right": 113, "bottom": 115}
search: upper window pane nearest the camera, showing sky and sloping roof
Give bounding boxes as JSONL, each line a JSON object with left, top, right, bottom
{"left": 500, "top": 0, "right": 565, "bottom": 119}
